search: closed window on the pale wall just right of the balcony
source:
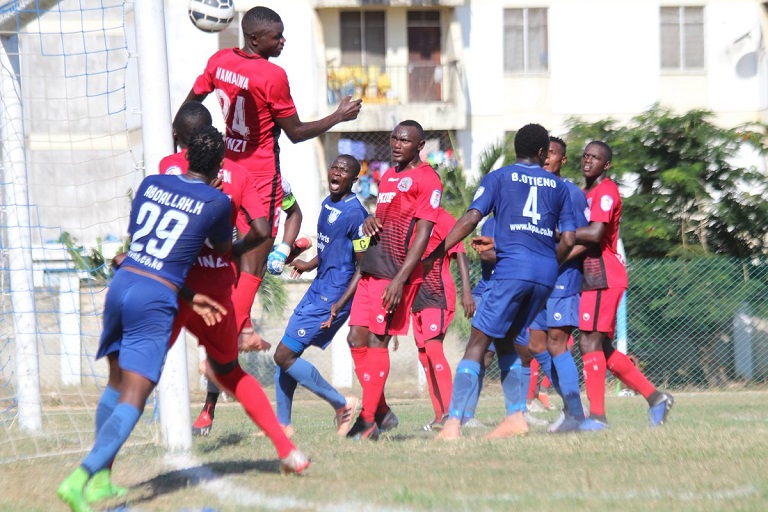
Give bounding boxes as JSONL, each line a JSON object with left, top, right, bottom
{"left": 504, "top": 8, "right": 549, "bottom": 73}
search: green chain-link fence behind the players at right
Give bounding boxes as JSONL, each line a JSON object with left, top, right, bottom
{"left": 454, "top": 257, "right": 768, "bottom": 388}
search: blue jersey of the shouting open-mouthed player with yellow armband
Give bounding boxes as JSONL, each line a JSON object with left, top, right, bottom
{"left": 307, "top": 194, "right": 368, "bottom": 304}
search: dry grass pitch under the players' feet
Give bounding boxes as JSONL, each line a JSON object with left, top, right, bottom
{"left": 0, "top": 385, "right": 768, "bottom": 512}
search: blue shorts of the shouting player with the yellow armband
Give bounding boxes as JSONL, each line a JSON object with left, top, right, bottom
{"left": 281, "top": 294, "right": 351, "bottom": 354}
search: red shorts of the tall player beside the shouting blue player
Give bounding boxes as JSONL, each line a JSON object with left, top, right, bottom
{"left": 349, "top": 275, "right": 421, "bottom": 336}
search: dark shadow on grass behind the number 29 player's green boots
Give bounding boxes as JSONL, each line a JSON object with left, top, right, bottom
{"left": 131, "top": 460, "right": 280, "bottom": 505}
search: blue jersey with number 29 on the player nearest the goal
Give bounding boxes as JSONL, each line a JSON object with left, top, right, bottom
{"left": 123, "top": 175, "right": 232, "bottom": 288}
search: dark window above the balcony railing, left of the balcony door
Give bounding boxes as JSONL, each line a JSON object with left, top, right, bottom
{"left": 340, "top": 11, "right": 386, "bottom": 66}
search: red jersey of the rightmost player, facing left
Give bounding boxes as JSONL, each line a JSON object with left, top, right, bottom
{"left": 582, "top": 178, "right": 627, "bottom": 290}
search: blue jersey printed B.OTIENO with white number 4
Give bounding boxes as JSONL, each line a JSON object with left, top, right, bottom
{"left": 469, "top": 163, "right": 576, "bottom": 287}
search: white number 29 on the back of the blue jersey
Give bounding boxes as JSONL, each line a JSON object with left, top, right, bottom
{"left": 131, "top": 203, "right": 189, "bottom": 260}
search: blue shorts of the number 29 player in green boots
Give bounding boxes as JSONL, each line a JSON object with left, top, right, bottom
{"left": 96, "top": 270, "right": 178, "bottom": 383}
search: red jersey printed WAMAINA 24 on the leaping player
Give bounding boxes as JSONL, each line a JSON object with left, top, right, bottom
{"left": 193, "top": 48, "right": 296, "bottom": 176}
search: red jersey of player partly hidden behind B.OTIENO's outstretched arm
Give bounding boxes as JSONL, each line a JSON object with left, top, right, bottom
{"left": 412, "top": 207, "right": 466, "bottom": 311}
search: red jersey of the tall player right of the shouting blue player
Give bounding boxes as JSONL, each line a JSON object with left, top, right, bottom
{"left": 361, "top": 162, "right": 443, "bottom": 284}
